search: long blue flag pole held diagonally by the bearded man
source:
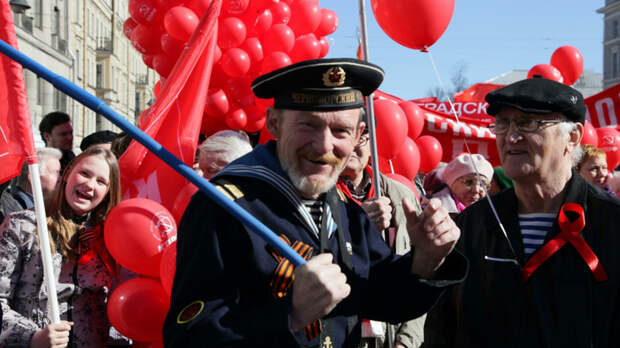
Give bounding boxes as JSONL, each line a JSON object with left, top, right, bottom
{"left": 0, "top": 40, "right": 306, "bottom": 266}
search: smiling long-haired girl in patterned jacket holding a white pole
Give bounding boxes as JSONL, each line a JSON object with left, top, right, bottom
{"left": 0, "top": 147, "right": 121, "bottom": 348}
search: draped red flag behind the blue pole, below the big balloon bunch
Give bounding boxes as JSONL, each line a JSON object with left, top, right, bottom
{"left": 119, "top": 0, "right": 221, "bottom": 209}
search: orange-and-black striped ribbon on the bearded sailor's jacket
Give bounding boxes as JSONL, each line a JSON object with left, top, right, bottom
{"left": 269, "top": 234, "right": 321, "bottom": 340}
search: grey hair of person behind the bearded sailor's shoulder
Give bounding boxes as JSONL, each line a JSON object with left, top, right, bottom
{"left": 199, "top": 130, "right": 252, "bottom": 162}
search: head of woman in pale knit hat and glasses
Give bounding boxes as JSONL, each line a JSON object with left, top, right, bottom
{"left": 432, "top": 154, "right": 493, "bottom": 215}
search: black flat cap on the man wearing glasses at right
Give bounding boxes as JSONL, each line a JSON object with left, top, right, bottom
{"left": 485, "top": 77, "right": 586, "bottom": 124}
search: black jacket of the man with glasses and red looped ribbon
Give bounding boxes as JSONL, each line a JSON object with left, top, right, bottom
{"left": 424, "top": 171, "right": 620, "bottom": 348}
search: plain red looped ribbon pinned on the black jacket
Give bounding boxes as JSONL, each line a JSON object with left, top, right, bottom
{"left": 521, "top": 203, "right": 607, "bottom": 283}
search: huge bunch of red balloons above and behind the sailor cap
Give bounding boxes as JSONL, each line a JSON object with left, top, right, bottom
{"left": 123, "top": 0, "right": 338, "bottom": 135}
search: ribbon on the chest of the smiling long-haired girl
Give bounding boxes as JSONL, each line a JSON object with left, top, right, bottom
{"left": 77, "top": 225, "right": 116, "bottom": 276}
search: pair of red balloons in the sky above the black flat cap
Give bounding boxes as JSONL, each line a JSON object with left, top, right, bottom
{"left": 527, "top": 46, "right": 583, "bottom": 86}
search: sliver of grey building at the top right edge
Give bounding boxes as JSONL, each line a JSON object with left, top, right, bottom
{"left": 596, "top": 0, "right": 620, "bottom": 89}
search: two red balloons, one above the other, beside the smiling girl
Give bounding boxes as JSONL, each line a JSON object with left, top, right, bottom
{"left": 104, "top": 198, "right": 177, "bottom": 345}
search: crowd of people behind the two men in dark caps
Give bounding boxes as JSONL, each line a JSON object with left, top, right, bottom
{"left": 0, "top": 102, "right": 620, "bottom": 347}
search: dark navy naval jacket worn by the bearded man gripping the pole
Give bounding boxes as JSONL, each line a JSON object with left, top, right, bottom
{"left": 164, "top": 142, "right": 467, "bottom": 348}
